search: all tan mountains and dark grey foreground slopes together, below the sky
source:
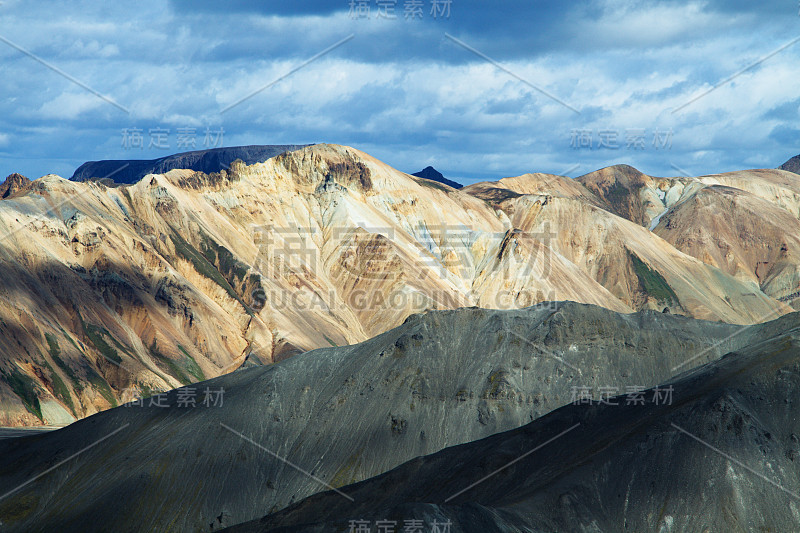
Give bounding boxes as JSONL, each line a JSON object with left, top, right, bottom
{"left": 0, "top": 144, "right": 800, "bottom": 533}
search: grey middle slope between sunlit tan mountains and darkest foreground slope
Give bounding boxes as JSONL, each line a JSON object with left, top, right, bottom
{"left": 0, "top": 303, "right": 780, "bottom": 532}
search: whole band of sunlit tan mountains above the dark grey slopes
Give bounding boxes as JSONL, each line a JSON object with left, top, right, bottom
{"left": 0, "top": 144, "right": 800, "bottom": 426}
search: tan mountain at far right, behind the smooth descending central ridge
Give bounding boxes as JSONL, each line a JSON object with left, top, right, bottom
{"left": 575, "top": 165, "right": 800, "bottom": 307}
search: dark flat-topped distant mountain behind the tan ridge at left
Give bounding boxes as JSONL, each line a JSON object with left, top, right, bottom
{"left": 70, "top": 144, "right": 310, "bottom": 184}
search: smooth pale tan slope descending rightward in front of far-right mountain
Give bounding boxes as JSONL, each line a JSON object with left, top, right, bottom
{"left": 500, "top": 195, "right": 780, "bottom": 321}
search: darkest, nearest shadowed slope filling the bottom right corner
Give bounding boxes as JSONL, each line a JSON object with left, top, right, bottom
{"left": 229, "top": 315, "right": 800, "bottom": 533}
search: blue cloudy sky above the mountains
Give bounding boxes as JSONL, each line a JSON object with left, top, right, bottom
{"left": 0, "top": 0, "right": 800, "bottom": 183}
